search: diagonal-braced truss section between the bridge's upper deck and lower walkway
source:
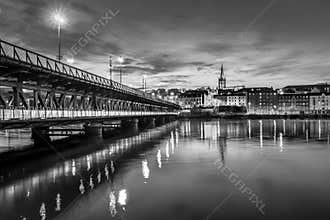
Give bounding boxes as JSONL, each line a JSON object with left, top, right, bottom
{"left": 0, "top": 82, "right": 168, "bottom": 111}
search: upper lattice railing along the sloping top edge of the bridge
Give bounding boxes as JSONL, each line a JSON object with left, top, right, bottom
{"left": 0, "top": 39, "right": 179, "bottom": 109}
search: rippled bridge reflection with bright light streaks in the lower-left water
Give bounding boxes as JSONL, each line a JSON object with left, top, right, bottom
{"left": 0, "top": 122, "right": 179, "bottom": 219}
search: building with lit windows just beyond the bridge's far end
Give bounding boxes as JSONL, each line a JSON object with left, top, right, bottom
{"left": 178, "top": 90, "right": 208, "bottom": 109}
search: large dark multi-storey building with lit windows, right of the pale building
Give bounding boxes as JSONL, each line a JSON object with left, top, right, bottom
{"left": 244, "top": 87, "right": 278, "bottom": 114}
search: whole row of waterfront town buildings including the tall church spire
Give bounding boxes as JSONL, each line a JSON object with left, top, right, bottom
{"left": 152, "top": 69, "right": 330, "bottom": 114}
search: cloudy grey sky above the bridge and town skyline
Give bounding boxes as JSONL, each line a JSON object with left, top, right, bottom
{"left": 0, "top": 0, "right": 330, "bottom": 88}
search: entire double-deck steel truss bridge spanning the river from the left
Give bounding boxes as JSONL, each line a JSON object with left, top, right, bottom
{"left": 0, "top": 40, "right": 179, "bottom": 145}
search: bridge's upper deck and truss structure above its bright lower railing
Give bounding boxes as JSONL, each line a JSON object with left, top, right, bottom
{"left": 0, "top": 40, "right": 179, "bottom": 120}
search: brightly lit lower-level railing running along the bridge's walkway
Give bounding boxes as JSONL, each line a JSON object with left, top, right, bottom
{"left": 0, "top": 109, "right": 178, "bottom": 121}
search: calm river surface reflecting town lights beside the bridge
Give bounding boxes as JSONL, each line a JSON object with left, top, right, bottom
{"left": 0, "top": 120, "right": 330, "bottom": 220}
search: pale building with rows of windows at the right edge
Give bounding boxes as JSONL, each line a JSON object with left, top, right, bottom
{"left": 309, "top": 93, "right": 330, "bottom": 115}
